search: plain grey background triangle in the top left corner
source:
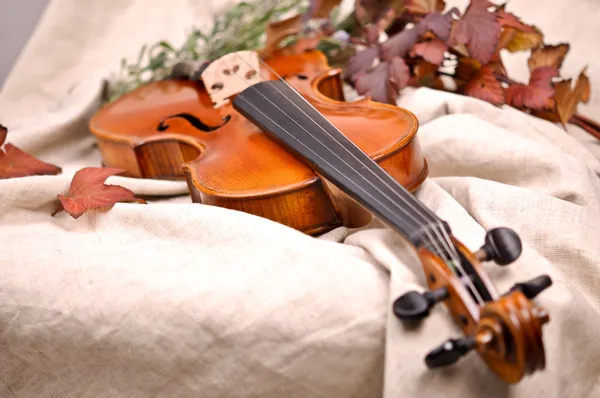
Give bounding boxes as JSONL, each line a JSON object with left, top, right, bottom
{"left": 0, "top": 0, "right": 49, "bottom": 90}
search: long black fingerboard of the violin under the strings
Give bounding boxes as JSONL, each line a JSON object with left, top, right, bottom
{"left": 233, "top": 80, "right": 450, "bottom": 247}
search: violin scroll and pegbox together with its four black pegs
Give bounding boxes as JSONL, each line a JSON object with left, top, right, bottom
{"left": 393, "top": 228, "right": 552, "bottom": 383}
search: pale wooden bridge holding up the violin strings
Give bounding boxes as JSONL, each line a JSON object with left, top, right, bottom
{"left": 201, "top": 51, "right": 263, "bottom": 108}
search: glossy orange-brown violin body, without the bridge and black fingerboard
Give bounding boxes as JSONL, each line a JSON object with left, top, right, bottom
{"left": 89, "top": 50, "right": 427, "bottom": 234}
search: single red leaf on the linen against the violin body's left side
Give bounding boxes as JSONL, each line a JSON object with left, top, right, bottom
{"left": 58, "top": 167, "right": 146, "bottom": 218}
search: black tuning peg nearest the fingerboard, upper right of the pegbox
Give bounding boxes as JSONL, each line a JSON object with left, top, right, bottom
{"left": 475, "top": 227, "right": 522, "bottom": 265}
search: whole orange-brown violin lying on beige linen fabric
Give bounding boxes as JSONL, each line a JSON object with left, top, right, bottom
{"left": 90, "top": 41, "right": 552, "bottom": 383}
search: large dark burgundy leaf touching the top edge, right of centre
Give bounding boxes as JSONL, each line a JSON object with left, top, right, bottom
{"left": 450, "top": 1, "right": 500, "bottom": 64}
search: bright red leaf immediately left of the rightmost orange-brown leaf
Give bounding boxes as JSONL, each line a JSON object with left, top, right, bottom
{"left": 505, "top": 66, "right": 558, "bottom": 110}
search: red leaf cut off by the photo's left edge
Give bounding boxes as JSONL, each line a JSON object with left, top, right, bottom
{"left": 0, "top": 124, "right": 62, "bottom": 179}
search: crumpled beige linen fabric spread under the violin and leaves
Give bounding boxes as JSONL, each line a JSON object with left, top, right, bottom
{"left": 0, "top": 0, "right": 600, "bottom": 398}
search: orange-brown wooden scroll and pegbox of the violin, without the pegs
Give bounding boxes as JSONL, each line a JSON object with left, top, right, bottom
{"left": 418, "top": 239, "right": 548, "bottom": 384}
